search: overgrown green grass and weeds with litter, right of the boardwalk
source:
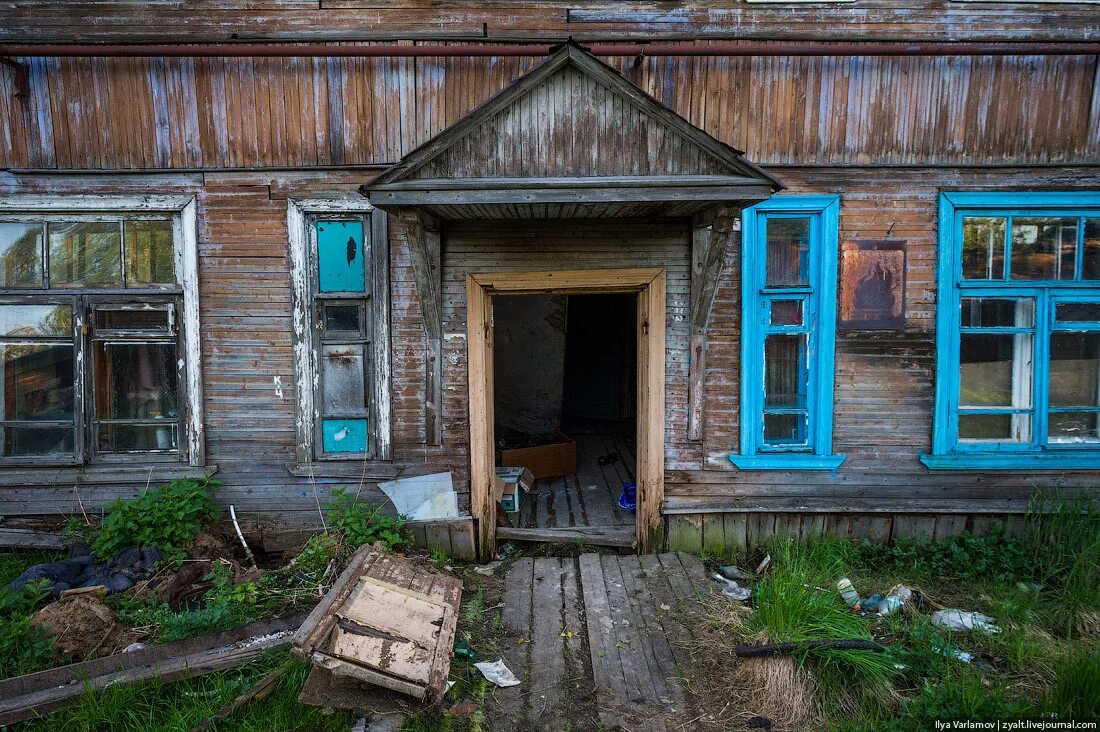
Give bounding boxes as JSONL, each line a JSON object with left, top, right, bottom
{"left": 690, "top": 498, "right": 1100, "bottom": 732}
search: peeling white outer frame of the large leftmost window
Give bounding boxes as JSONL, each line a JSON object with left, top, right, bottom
{"left": 0, "top": 194, "right": 206, "bottom": 468}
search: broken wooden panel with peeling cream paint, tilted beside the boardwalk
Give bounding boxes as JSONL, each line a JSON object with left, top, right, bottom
{"left": 294, "top": 543, "right": 462, "bottom": 701}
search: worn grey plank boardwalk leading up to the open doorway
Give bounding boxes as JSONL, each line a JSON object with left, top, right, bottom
{"left": 493, "top": 554, "right": 712, "bottom": 732}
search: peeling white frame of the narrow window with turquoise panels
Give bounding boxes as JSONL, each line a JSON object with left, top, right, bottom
{"left": 286, "top": 196, "right": 393, "bottom": 462}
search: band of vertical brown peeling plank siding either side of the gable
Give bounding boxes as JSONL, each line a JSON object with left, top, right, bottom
{"left": 0, "top": 52, "right": 1100, "bottom": 170}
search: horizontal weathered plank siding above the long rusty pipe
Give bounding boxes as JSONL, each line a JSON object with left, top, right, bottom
{"left": 0, "top": 0, "right": 1100, "bottom": 43}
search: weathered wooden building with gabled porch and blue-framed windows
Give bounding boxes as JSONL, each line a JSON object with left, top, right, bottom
{"left": 0, "top": 0, "right": 1100, "bottom": 555}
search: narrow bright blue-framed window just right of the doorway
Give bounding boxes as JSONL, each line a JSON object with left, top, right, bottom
{"left": 729, "top": 196, "right": 844, "bottom": 470}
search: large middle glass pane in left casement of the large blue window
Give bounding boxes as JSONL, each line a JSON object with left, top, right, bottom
{"left": 959, "top": 334, "right": 1032, "bottom": 409}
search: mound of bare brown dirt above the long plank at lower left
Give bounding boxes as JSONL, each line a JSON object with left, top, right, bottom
{"left": 31, "top": 594, "right": 142, "bottom": 662}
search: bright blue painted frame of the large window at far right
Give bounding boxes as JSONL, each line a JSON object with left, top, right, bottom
{"left": 921, "top": 193, "right": 1100, "bottom": 470}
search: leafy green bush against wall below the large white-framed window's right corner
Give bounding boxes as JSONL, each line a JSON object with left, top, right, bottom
{"left": 91, "top": 479, "right": 221, "bottom": 561}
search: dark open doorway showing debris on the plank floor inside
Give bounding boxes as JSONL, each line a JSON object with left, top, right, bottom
{"left": 493, "top": 294, "right": 638, "bottom": 546}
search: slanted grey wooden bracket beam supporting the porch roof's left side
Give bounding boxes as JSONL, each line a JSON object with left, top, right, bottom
{"left": 397, "top": 209, "right": 443, "bottom": 445}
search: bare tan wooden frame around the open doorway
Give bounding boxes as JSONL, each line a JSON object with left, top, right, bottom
{"left": 466, "top": 267, "right": 666, "bottom": 559}
